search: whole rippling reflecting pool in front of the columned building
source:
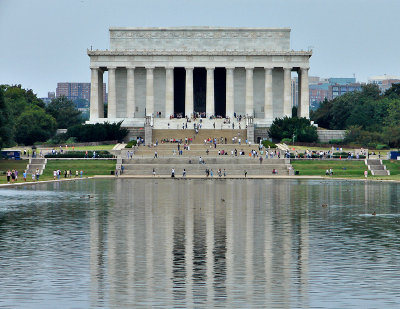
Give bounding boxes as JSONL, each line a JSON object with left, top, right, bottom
{"left": 0, "top": 179, "right": 400, "bottom": 308}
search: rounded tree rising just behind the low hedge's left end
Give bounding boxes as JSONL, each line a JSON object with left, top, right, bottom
{"left": 46, "top": 96, "right": 82, "bottom": 129}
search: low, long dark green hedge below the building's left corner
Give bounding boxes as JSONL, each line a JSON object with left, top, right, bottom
{"left": 67, "top": 121, "right": 128, "bottom": 142}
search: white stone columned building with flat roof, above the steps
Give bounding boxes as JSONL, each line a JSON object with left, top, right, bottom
{"left": 88, "top": 27, "right": 311, "bottom": 126}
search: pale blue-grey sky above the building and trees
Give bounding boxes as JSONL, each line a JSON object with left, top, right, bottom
{"left": 0, "top": 0, "right": 400, "bottom": 97}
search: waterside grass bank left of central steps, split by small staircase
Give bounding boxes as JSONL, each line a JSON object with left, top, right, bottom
{"left": 0, "top": 160, "right": 117, "bottom": 184}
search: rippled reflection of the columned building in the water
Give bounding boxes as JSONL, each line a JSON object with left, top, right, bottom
{"left": 90, "top": 179, "right": 313, "bottom": 308}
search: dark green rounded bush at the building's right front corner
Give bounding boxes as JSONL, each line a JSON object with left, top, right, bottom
{"left": 268, "top": 117, "right": 318, "bottom": 143}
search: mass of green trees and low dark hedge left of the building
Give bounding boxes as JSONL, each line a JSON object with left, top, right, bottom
{"left": 0, "top": 85, "right": 127, "bottom": 149}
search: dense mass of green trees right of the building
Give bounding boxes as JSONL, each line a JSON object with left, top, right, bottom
{"left": 310, "top": 84, "right": 400, "bottom": 148}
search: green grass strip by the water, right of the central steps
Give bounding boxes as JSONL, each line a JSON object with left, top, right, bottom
{"left": 291, "top": 160, "right": 371, "bottom": 178}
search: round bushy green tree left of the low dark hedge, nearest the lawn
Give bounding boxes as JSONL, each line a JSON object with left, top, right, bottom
{"left": 15, "top": 106, "right": 57, "bottom": 145}
